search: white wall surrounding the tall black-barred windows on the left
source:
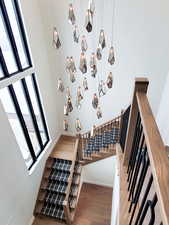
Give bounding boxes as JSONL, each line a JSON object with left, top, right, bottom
{"left": 0, "top": 0, "right": 62, "bottom": 225}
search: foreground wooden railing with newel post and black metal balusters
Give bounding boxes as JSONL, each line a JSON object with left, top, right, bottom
{"left": 120, "top": 78, "right": 169, "bottom": 225}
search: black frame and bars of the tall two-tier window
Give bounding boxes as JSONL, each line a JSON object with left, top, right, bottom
{"left": 0, "top": 0, "right": 50, "bottom": 170}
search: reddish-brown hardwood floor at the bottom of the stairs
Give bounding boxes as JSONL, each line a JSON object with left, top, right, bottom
{"left": 32, "top": 183, "right": 113, "bottom": 225}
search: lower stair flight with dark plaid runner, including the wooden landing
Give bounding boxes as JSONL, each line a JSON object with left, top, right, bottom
{"left": 34, "top": 136, "right": 82, "bottom": 224}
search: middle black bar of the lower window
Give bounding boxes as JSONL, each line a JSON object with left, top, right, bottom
{"left": 21, "top": 78, "right": 43, "bottom": 151}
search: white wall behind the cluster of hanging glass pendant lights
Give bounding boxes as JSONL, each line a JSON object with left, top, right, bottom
{"left": 39, "top": 0, "right": 169, "bottom": 188}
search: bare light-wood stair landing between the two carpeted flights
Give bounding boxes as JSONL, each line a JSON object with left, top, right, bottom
{"left": 50, "top": 135, "right": 76, "bottom": 160}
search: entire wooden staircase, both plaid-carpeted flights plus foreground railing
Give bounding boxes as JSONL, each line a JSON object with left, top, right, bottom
{"left": 34, "top": 78, "right": 169, "bottom": 225}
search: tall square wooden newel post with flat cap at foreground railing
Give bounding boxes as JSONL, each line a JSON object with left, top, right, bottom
{"left": 123, "top": 78, "right": 149, "bottom": 166}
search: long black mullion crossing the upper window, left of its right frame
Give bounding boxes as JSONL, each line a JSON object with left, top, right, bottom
{"left": 0, "top": 0, "right": 22, "bottom": 71}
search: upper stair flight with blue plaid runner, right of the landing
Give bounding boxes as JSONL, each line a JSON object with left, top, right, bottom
{"left": 79, "top": 117, "right": 121, "bottom": 165}
